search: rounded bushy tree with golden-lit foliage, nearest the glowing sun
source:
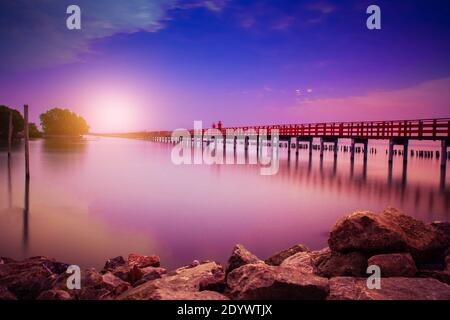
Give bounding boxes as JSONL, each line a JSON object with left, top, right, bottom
{"left": 40, "top": 108, "right": 89, "bottom": 136}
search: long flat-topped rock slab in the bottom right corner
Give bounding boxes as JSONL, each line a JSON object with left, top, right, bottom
{"left": 328, "top": 277, "right": 450, "bottom": 300}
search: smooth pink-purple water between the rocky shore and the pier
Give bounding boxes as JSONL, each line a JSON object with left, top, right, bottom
{"left": 0, "top": 137, "right": 450, "bottom": 268}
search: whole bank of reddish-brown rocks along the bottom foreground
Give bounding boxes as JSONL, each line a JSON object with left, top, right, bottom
{"left": 0, "top": 208, "right": 450, "bottom": 300}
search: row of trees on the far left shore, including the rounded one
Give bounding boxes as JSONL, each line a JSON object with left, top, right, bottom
{"left": 0, "top": 105, "right": 89, "bottom": 139}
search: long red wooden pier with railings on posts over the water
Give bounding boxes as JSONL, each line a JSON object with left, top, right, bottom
{"left": 141, "top": 118, "right": 450, "bottom": 166}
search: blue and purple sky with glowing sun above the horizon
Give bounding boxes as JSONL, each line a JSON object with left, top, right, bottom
{"left": 0, "top": 0, "right": 450, "bottom": 131}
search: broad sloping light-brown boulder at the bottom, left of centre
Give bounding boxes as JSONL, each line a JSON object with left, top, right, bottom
{"left": 118, "top": 262, "right": 224, "bottom": 300}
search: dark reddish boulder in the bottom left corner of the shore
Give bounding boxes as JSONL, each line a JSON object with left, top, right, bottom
{"left": 0, "top": 256, "right": 68, "bottom": 300}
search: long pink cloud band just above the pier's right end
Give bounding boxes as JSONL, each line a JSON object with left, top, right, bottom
{"left": 289, "top": 78, "right": 450, "bottom": 122}
